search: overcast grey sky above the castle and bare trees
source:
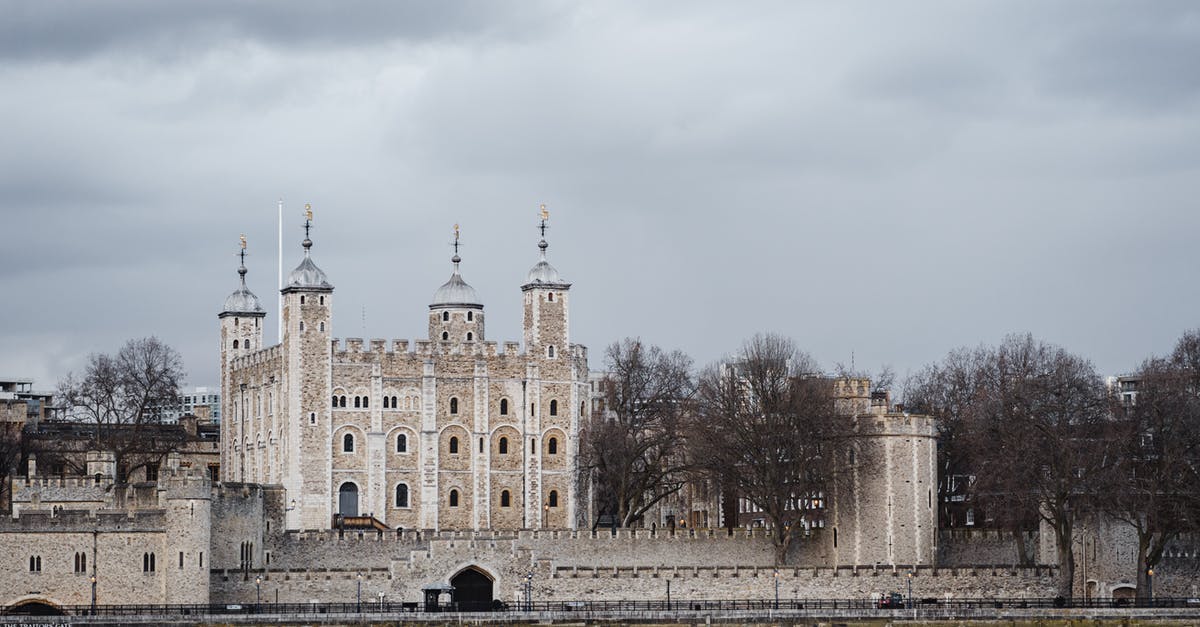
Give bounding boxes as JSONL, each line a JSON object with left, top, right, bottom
{"left": 0, "top": 0, "right": 1200, "bottom": 388}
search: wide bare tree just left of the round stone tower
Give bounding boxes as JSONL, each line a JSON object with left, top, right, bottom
{"left": 689, "top": 335, "right": 850, "bottom": 563}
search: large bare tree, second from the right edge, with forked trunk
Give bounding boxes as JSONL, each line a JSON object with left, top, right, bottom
{"left": 964, "top": 335, "right": 1116, "bottom": 598}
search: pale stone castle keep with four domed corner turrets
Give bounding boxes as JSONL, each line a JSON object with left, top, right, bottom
{"left": 220, "top": 214, "right": 589, "bottom": 530}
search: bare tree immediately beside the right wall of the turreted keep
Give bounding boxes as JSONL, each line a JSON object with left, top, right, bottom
{"left": 581, "top": 338, "right": 695, "bottom": 526}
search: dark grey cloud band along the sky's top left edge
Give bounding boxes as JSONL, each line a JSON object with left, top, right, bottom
{"left": 0, "top": 0, "right": 559, "bottom": 61}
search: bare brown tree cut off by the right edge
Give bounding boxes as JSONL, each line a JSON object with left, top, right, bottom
{"left": 1103, "top": 332, "right": 1200, "bottom": 598}
